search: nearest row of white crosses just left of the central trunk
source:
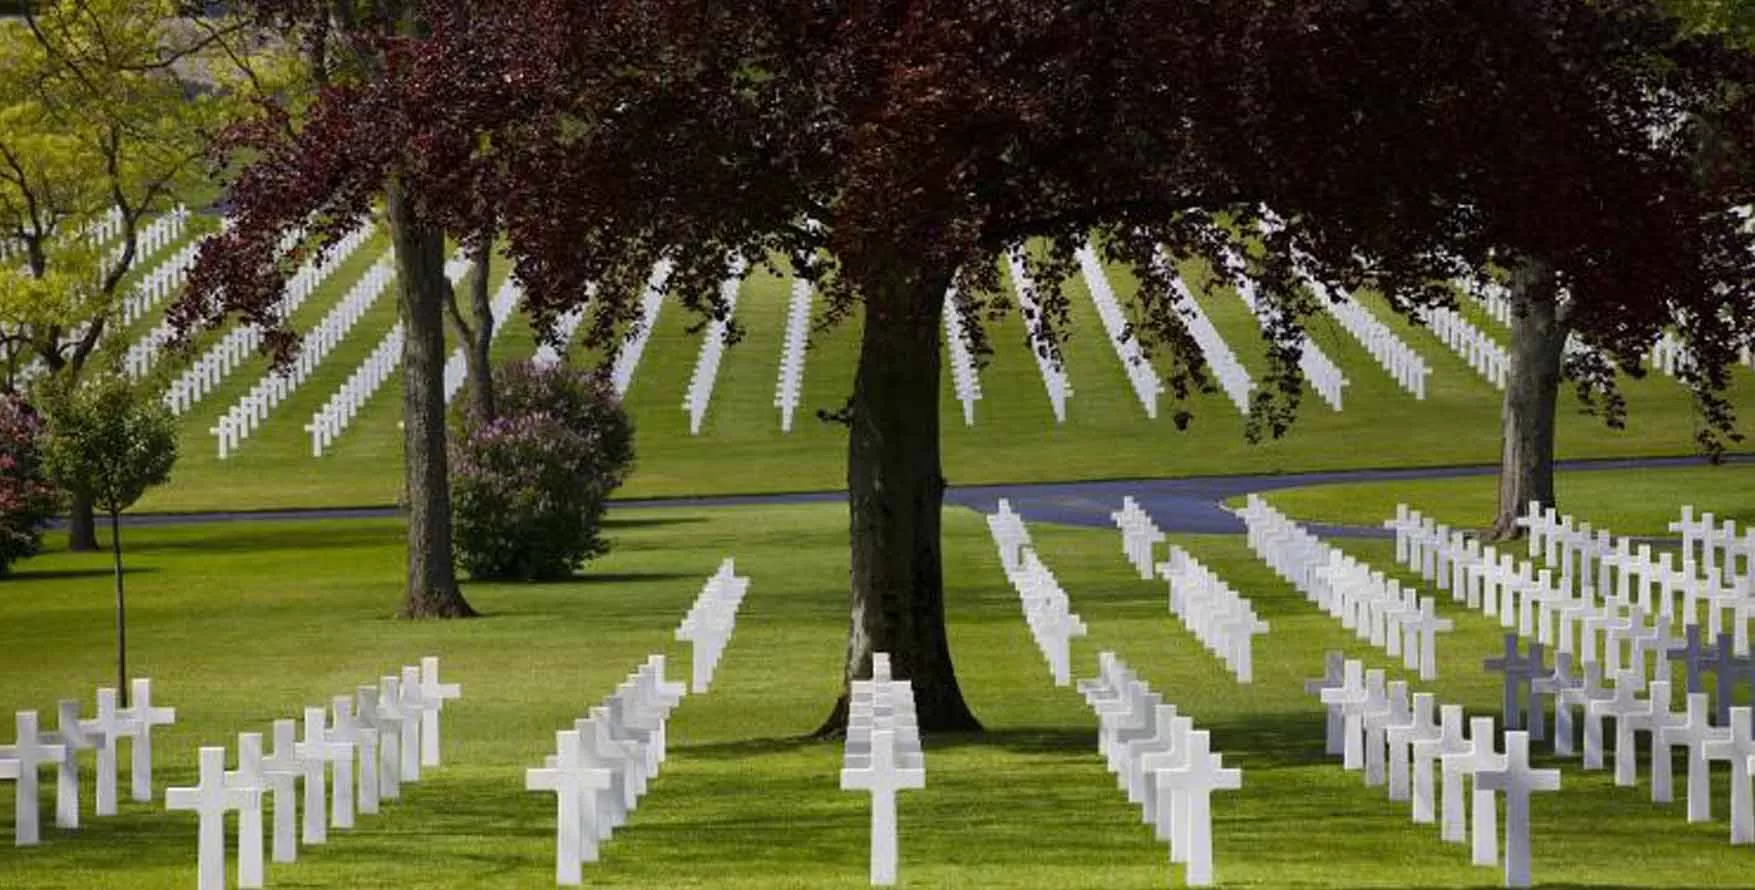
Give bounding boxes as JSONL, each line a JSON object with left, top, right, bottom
{"left": 525, "top": 655, "right": 684, "bottom": 886}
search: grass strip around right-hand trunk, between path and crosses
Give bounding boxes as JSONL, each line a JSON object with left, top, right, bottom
{"left": 1229, "top": 463, "right": 1755, "bottom": 537}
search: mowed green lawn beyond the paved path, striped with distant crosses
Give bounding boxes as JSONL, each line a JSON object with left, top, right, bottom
{"left": 127, "top": 242, "right": 1755, "bottom": 511}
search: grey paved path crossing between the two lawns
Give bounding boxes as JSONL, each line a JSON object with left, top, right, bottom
{"left": 102, "top": 455, "right": 1755, "bottom": 537}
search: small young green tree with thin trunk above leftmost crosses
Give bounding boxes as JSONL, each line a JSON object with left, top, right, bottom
{"left": 44, "top": 376, "right": 177, "bottom": 704}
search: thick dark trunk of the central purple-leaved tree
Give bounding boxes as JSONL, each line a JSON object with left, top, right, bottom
{"left": 818, "top": 265, "right": 981, "bottom": 736}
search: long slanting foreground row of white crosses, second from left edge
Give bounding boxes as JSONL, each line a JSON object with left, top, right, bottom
{"left": 165, "top": 657, "right": 463, "bottom": 890}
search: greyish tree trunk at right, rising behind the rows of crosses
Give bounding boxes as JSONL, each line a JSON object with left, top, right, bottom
{"left": 1490, "top": 260, "right": 1567, "bottom": 541}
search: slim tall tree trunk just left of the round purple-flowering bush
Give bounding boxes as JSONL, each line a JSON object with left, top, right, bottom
{"left": 384, "top": 179, "right": 476, "bottom": 618}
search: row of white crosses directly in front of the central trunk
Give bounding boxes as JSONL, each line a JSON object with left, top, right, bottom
{"left": 841, "top": 651, "right": 927, "bottom": 886}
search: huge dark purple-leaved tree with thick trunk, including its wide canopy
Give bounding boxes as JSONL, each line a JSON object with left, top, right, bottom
{"left": 183, "top": 0, "right": 1755, "bottom": 732}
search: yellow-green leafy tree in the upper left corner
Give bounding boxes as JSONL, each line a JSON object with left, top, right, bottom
{"left": 0, "top": 0, "right": 276, "bottom": 549}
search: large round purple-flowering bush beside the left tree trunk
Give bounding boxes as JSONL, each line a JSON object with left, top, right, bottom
{"left": 451, "top": 362, "right": 634, "bottom": 581}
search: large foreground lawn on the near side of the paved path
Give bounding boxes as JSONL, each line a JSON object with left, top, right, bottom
{"left": 0, "top": 500, "right": 1750, "bottom": 890}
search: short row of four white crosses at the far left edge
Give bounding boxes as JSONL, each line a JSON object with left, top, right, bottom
{"left": 0, "top": 678, "right": 177, "bottom": 846}
